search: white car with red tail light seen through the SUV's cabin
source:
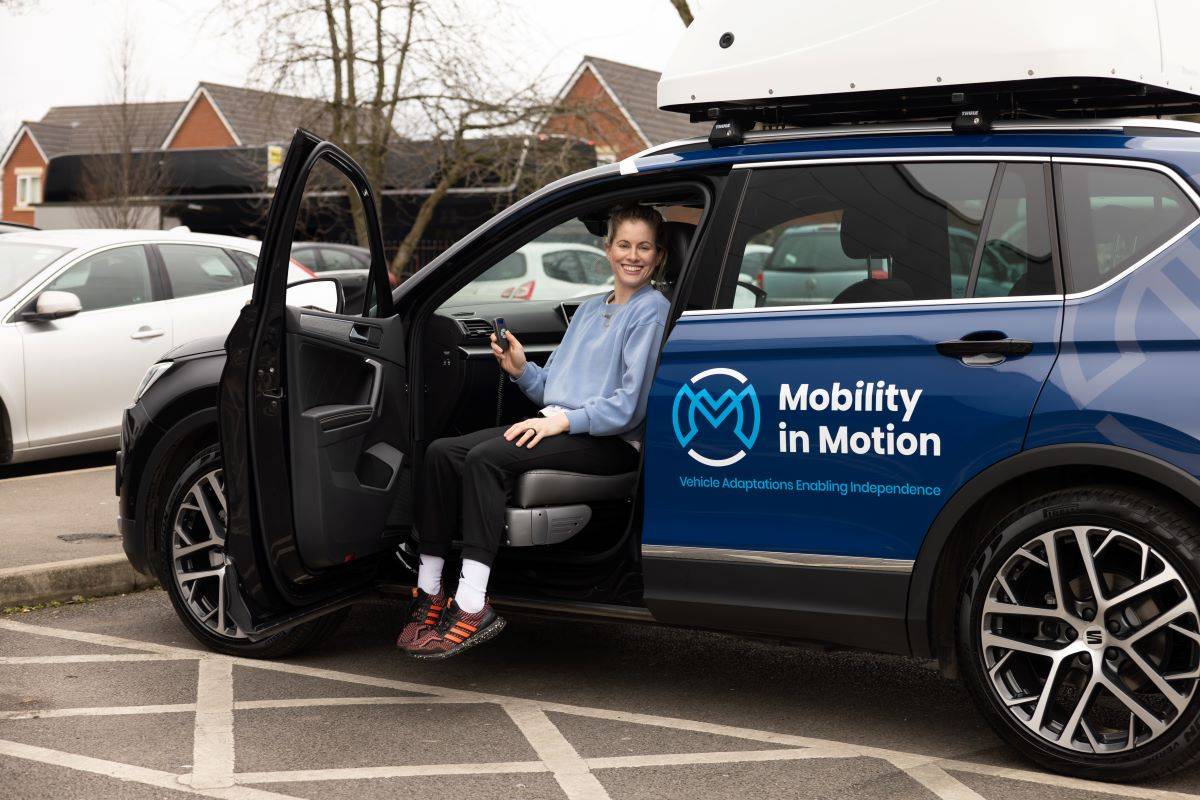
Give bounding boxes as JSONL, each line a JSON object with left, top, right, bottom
{"left": 446, "top": 241, "right": 612, "bottom": 305}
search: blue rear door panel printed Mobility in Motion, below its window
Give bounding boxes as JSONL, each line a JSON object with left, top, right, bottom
{"left": 643, "top": 300, "right": 1062, "bottom": 651}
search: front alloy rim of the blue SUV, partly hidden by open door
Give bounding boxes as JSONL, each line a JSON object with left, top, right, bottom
{"left": 170, "top": 469, "right": 246, "bottom": 639}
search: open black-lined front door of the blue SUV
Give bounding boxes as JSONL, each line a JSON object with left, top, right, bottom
{"left": 218, "top": 131, "right": 412, "bottom": 639}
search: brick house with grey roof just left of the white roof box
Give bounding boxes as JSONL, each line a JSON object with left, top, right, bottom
{"left": 541, "top": 55, "right": 713, "bottom": 162}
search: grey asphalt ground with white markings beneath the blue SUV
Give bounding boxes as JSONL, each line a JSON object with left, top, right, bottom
{"left": 0, "top": 590, "right": 1200, "bottom": 800}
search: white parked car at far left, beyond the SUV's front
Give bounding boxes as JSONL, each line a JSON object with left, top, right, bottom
{"left": 0, "top": 230, "right": 312, "bottom": 464}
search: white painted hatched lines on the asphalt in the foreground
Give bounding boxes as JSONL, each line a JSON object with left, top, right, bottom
{"left": 0, "top": 620, "right": 1200, "bottom": 800}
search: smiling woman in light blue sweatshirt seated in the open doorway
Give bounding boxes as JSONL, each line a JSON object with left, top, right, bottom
{"left": 397, "top": 205, "right": 670, "bottom": 658}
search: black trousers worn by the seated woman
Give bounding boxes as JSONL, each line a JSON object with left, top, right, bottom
{"left": 416, "top": 426, "right": 640, "bottom": 565}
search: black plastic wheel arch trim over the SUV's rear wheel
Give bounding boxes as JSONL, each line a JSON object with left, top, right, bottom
{"left": 907, "top": 444, "right": 1200, "bottom": 676}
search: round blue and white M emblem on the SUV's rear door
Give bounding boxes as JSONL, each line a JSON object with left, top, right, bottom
{"left": 671, "top": 367, "right": 762, "bottom": 467}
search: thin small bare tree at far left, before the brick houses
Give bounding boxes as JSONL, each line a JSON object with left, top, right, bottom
{"left": 80, "top": 25, "right": 163, "bottom": 228}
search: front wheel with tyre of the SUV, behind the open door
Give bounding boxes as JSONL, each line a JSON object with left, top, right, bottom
{"left": 157, "top": 445, "right": 349, "bottom": 658}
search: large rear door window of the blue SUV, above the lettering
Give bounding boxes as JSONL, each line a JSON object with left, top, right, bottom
{"left": 724, "top": 162, "right": 997, "bottom": 306}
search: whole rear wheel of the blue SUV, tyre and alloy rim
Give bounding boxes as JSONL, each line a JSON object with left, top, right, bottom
{"left": 955, "top": 487, "right": 1200, "bottom": 781}
